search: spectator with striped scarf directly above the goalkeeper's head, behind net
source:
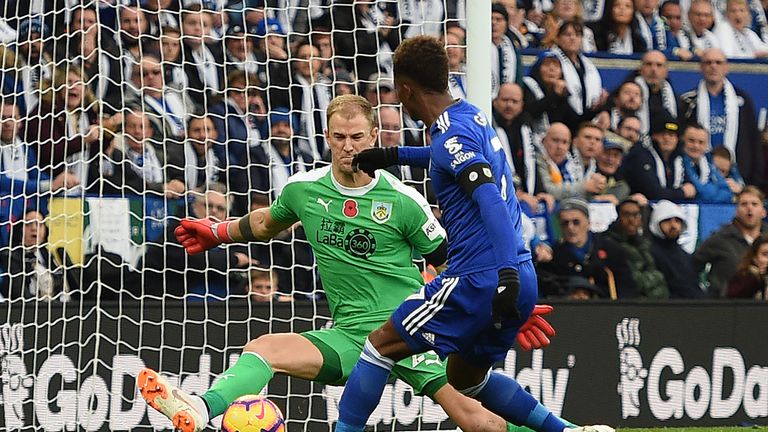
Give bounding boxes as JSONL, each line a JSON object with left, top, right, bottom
{"left": 289, "top": 43, "right": 333, "bottom": 160}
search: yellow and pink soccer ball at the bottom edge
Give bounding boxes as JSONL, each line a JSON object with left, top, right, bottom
{"left": 221, "top": 395, "right": 285, "bottom": 432}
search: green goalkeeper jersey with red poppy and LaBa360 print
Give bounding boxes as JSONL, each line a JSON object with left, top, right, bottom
{"left": 270, "top": 166, "right": 445, "bottom": 328}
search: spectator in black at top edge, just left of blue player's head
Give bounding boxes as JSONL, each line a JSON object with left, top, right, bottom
{"left": 331, "top": 1, "right": 405, "bottom": 84}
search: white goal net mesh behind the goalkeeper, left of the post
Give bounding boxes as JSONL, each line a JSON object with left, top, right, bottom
{"left": 0, "top": 0, "right": 464, "bottom": 431}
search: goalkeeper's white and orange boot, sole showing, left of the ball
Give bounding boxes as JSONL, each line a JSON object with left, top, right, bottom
{"left": 136, "top": 368, "right": 207, "bottom": 432}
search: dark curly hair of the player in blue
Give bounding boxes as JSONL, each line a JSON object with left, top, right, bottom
{"left": 393, "top": 36, "right": 448, "bottom": 93}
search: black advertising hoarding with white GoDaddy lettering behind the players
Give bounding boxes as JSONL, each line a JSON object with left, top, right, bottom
{"left": 0, "top": 302, "right": 768, "bottom": 432}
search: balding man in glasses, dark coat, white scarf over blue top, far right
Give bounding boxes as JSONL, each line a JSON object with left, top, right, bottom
{"left": 680, "top": 48, "right": 765, "bottom": 185}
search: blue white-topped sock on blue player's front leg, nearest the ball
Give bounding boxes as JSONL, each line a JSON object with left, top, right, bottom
{"left": 336, "top": 339, "right": 395, "bottom": 432}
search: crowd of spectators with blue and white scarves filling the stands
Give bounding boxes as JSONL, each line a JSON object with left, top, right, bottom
{"left": 0, "top": 0, "right": 768, "bottom": 301}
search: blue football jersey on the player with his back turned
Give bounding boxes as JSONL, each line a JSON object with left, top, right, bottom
{"left": 429, "top": 100, "right": 531, "bottom": 275}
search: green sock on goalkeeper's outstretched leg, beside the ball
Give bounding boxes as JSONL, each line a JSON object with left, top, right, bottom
{"left": 201, "top": 351, "right": 274, "bottom": 418}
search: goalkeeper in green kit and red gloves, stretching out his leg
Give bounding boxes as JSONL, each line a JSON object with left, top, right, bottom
{"left": 137, "top": 95, "right": 554, "bottom": 432}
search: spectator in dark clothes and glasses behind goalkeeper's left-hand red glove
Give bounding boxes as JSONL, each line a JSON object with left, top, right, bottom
{"left": 144, "top": 183, "right": 258, "bottom": 300}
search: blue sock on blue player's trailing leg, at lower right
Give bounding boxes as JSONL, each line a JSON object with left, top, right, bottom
{"left": 472, "top": 372, "right": 566, "bottom": 432}
